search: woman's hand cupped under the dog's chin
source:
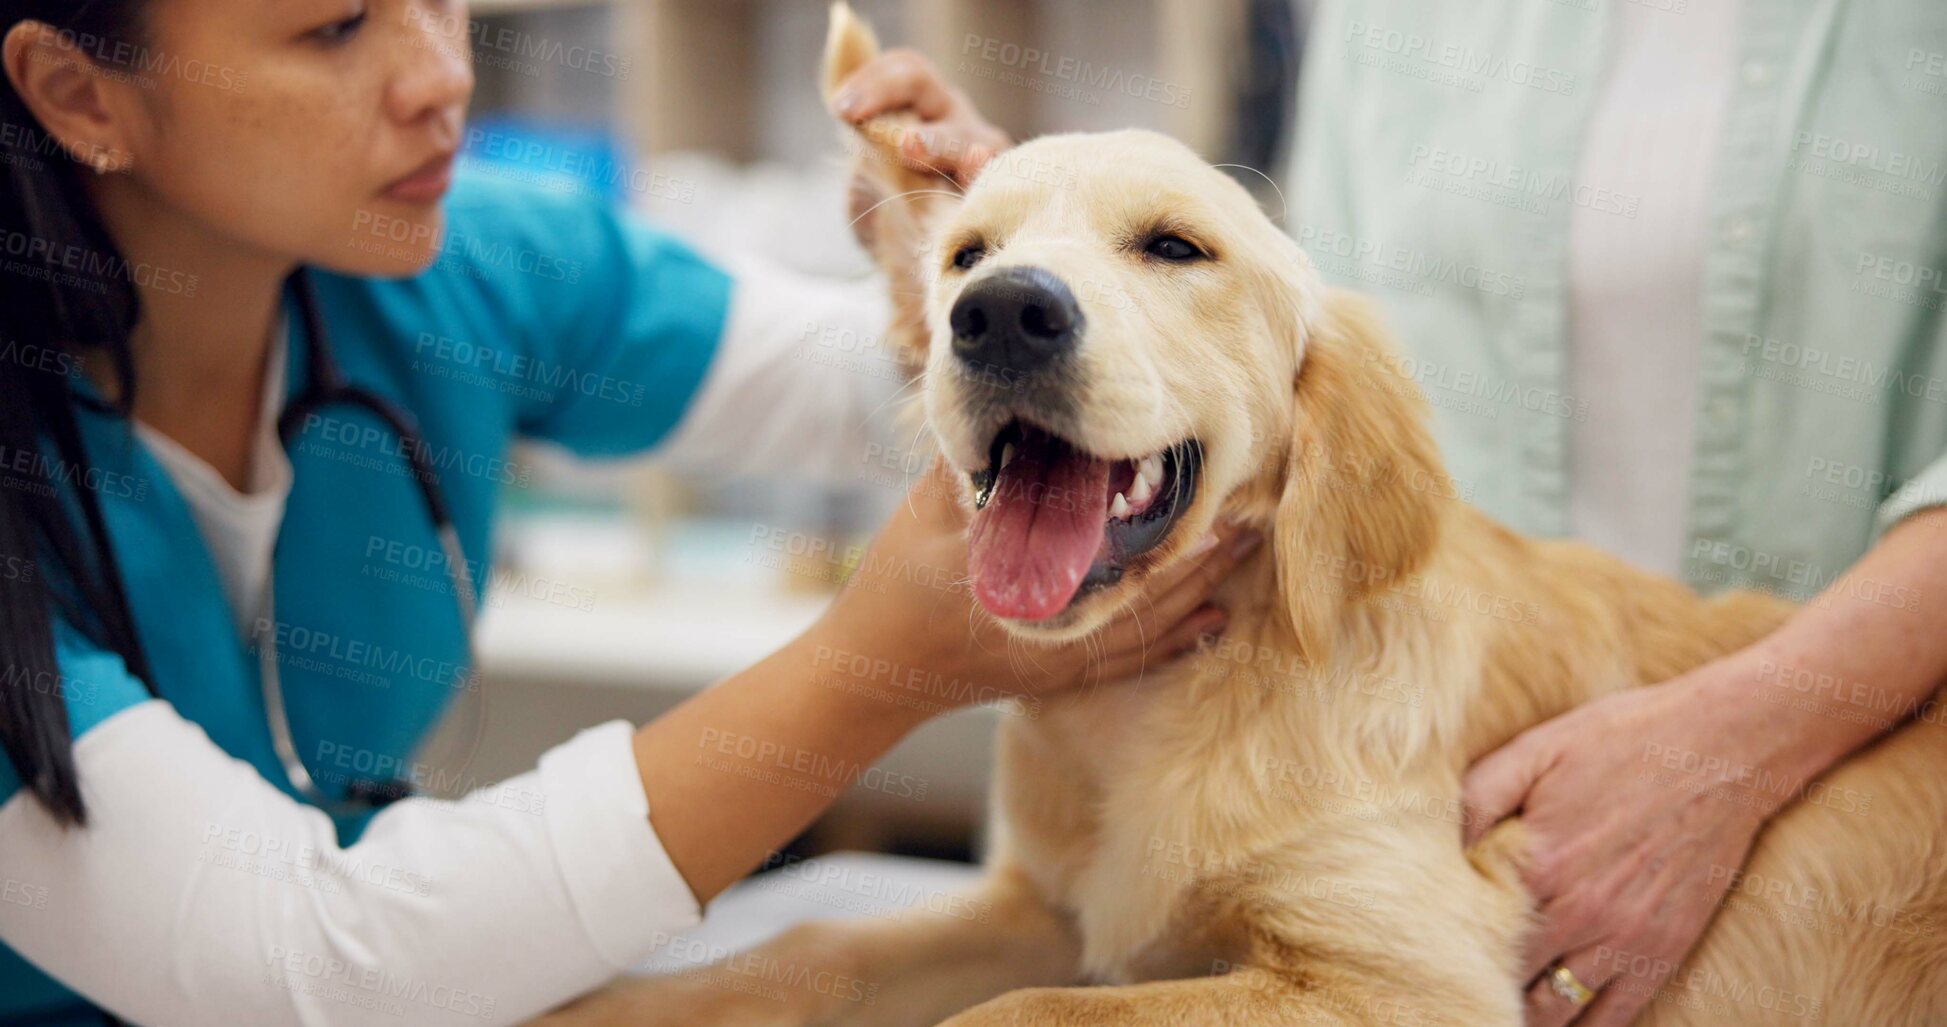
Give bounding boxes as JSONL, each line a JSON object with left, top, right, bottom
{"left": 814, "top": 460, "right": 1260, "bottom": 713}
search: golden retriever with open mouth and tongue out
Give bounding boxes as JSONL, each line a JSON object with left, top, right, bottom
{"left": 533, "top": 8, "right": 1947, "bottom": 1027}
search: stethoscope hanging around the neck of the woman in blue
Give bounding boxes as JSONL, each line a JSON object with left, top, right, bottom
{"left": 251, "top": 267, "right": 479, "bottom": 815}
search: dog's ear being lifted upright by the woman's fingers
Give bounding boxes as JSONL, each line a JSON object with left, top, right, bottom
{"left": 822, "top": 2, "right": 960, "bottom": 364}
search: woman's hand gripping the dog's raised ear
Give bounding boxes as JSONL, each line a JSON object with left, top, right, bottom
{"left": 831, "top": 49, "right": 1012, "bottom": 187}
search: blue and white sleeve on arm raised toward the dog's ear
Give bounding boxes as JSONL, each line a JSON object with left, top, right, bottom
{"left": 482, "top": 169, "right": 905, "bottom": 481}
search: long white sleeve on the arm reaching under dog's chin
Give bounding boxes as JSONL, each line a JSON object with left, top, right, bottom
{"left": 0, "top": 685, "right": 701, "bottom": 1025}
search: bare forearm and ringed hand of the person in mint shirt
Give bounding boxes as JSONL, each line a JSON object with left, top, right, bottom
{"left": 1466, "top": 511, "right": 1947, "bottom": 1027}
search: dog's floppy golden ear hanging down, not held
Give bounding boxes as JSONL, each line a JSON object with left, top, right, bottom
{"left": 1271, "top": 290, "right": 1449, "bottom": 665}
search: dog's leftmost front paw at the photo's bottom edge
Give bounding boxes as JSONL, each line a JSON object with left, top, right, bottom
{"left": 530, "top": 972, "right": 810, "bottom": 1027}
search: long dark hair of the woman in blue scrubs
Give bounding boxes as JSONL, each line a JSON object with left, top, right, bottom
{"left": 0, "top": 0, "right": 148, "bottom": 826}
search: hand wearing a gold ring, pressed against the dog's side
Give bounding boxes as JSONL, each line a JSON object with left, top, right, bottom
{"left": 1464, "top": 651, "right": 1824, "bottom": 1027}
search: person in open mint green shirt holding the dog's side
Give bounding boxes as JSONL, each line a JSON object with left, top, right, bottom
{"left": 1287, "top": 0, "right": 1947, "bottom": 1027}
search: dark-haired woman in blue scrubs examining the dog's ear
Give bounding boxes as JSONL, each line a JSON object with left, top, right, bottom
{"left": 0, "top": 0, "right": 1232, "bottom": 1025}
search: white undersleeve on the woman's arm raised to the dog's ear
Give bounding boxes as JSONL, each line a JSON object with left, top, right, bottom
{"left": 656, "top": 261, "right": 917, "bottom": 483}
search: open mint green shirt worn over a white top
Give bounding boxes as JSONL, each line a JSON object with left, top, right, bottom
{"left": 1287, "top": 0, "right": 1947, "bottom": 606}
